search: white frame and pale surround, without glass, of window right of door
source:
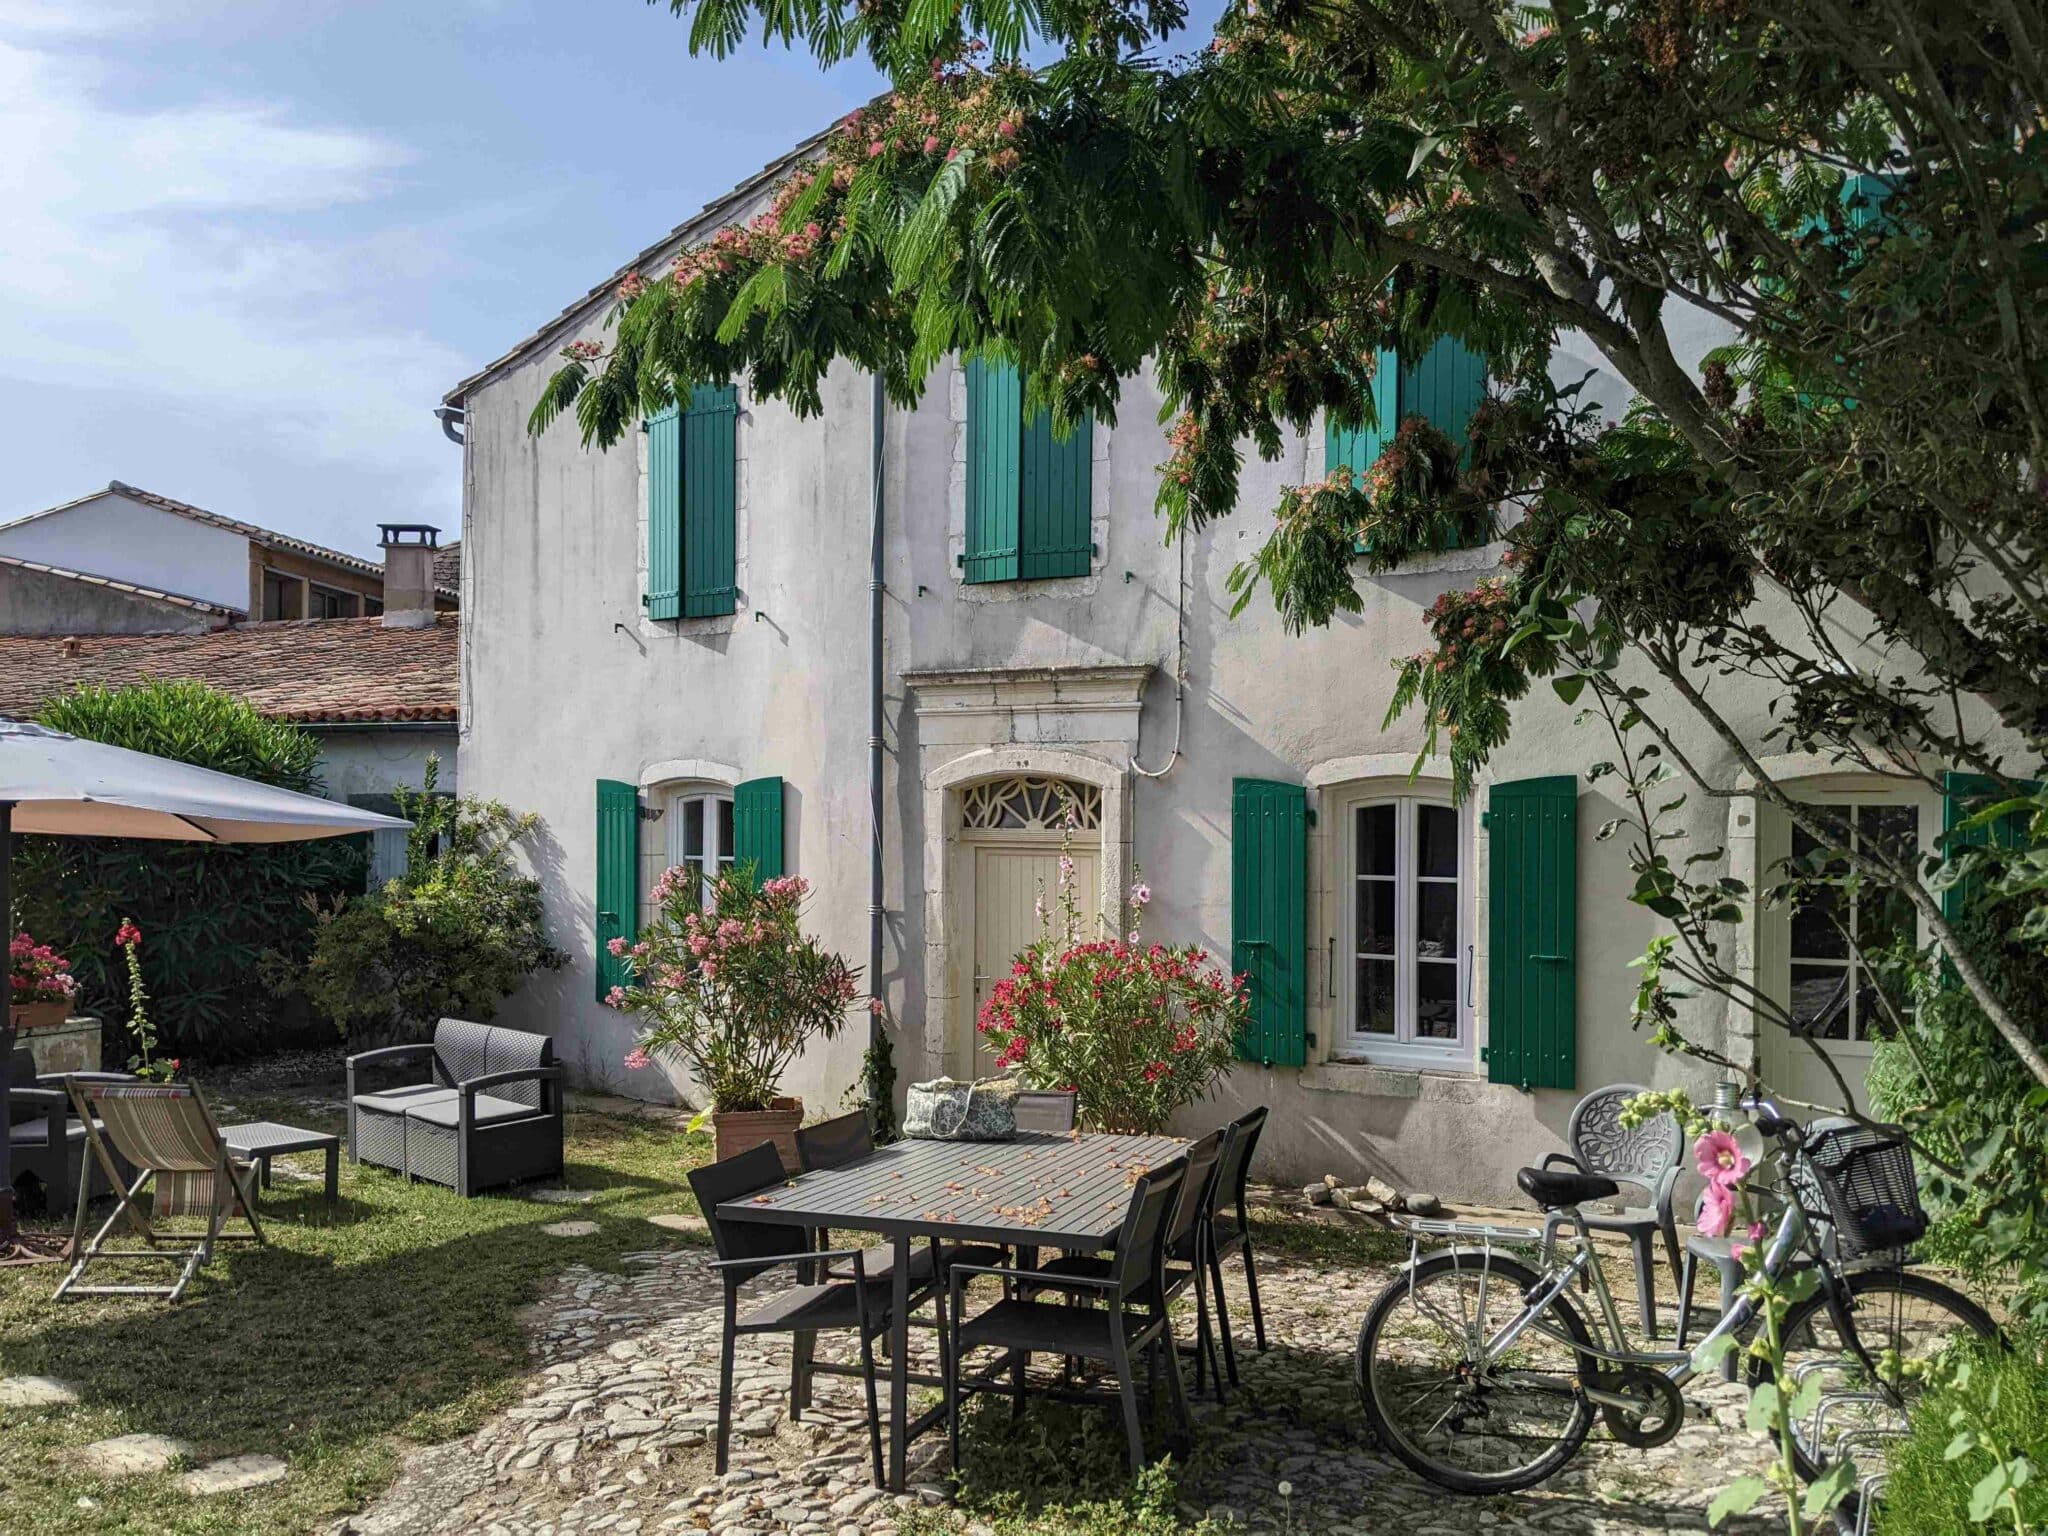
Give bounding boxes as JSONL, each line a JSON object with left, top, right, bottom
{"left": 1331, "top": 794, "right": 1479, "bottom": 1071}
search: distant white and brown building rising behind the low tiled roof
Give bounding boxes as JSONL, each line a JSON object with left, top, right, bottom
{"left": 0, "top": 479, "right": 459, "bottom": 635}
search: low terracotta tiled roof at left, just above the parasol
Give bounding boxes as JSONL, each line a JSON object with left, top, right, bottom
{"left": 0, "top": 612, "right": 461, "bottom": 725}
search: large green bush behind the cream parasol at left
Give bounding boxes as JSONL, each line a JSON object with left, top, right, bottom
{"left": 14, "top": 680, "right": 367, "bottom": 1057}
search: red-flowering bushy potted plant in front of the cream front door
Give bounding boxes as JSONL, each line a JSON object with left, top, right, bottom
{"left": 975, "top": 872, "right": 1249, "bottom": 1135}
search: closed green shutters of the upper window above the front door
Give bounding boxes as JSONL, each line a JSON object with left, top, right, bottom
{"left": 963, "top": 358, "right": 1096, "bottom": 582}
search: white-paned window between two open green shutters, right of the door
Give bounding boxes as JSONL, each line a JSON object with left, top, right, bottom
{"left": 1337, "top": 795, "right": 1470, "bottom": 1061}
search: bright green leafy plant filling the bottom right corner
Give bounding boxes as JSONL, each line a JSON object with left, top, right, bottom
{"left": 1874, "top": 1333, "right": 2048, "bottom": 1536}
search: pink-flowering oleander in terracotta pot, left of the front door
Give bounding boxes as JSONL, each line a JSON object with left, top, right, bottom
{"left": 606, "top": 864, "right": 858, "bottom": 1171}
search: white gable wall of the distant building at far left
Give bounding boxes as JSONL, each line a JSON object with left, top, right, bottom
{"left": 0, "top": 492, "right": 250, "bottom": 612}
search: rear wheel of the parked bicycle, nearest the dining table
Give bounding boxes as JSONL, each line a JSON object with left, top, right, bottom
{"left": 1358, "top": 1253, "right": 1595, "bottom": 1493}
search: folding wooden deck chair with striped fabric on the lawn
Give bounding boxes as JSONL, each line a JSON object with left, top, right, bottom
{"left": 55, "top": 1081, "right": 264, "bottom": 1300}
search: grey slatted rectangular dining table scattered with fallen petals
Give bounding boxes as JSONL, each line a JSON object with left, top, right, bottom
{"left": 720, "top": 1133, "right": 1186, "bottom": 1491}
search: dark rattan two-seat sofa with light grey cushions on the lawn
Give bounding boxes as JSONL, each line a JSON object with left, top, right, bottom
{"left": 348, "top": 1018, "right": 561, "bottom": 1196}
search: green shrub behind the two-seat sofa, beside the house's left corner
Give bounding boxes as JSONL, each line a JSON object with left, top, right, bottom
{"left": 290, "top": 758, "right": 567, "bottom": 1044}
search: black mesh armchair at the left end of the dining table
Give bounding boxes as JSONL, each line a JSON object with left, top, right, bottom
{"left": 690, "top": 1141, "right": 924, "bottom": 1487}
